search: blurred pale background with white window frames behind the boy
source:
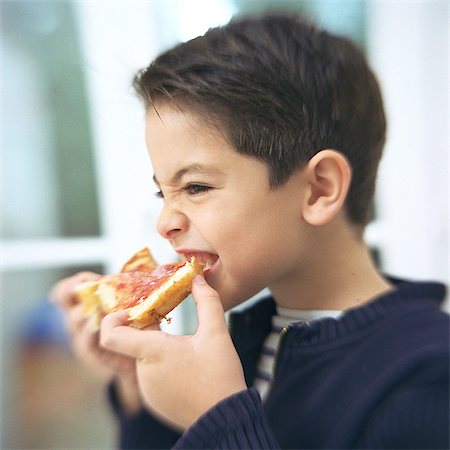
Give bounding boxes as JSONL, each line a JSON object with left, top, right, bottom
{"left": 0, "top": 0, "right": 449, "bottom": 449}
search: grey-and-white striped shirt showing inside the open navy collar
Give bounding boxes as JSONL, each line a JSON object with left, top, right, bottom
{"left": 254, "top": 306, "right": 342, "bottom": 400}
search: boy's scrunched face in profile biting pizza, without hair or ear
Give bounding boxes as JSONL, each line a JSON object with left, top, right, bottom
{"left": 146, "top": 105, "right": 305, "bottom": 310}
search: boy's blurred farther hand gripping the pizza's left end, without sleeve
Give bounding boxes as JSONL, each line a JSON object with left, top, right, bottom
{"left": 50, "top": 272, "right": 142, "bottom": 413}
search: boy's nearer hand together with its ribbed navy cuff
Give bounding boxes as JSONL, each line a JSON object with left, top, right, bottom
{"left": 101, "top": 277, "right": 278, "bottom": 448}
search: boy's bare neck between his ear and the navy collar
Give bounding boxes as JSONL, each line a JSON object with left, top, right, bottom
{"left": 271, "top": 219, "right": 393, "bottom": 311}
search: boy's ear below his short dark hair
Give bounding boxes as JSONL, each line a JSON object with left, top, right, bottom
{"left": 303, "top": 149, "right": 352, "bottom": 226}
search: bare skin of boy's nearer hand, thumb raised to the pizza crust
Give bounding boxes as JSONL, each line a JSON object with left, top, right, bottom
{"left": 101, "top": 277, "right": 246, "bottom": 429}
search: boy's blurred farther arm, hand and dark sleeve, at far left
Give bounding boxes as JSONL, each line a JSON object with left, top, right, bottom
{"left": 51, "top": 272, "right": 179, "bottom": 449}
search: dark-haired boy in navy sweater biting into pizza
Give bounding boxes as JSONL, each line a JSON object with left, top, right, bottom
{"left": 51, "top": 15, "right": 449, "bottom": 448}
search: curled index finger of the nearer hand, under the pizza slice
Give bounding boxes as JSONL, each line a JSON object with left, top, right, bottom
{"left": 100, "top": 310, "right": 165, "bottom": 359}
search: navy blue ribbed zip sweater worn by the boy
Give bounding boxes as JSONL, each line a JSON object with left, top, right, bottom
{"left": 111, "top": 281, "right": 450, "bottom": 449}
